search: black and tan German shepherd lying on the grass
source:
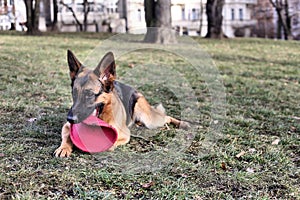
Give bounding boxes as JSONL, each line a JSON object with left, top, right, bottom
{"left": 54, "top": 50, "right": 189, "bottom": 157}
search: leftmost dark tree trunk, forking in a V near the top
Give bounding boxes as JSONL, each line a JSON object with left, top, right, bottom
{"left": 24, "top": 0, "right": 40, "bottom": 34}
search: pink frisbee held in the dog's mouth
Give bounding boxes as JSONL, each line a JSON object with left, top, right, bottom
{"left": 70, "top": 115, "right": 118, "bottom": 153}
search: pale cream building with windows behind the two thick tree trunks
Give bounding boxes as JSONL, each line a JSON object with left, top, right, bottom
{"left": 118, "top": 0, "right": 257, "bottom": 37}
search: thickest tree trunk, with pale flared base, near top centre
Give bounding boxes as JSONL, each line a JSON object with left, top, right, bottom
{"left": 144, "top": 0, "right": 176, "bottom": 44}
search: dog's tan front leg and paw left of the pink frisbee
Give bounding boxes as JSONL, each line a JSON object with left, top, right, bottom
{"left": 54, "top": 122, "right": 73, "bottom": 157}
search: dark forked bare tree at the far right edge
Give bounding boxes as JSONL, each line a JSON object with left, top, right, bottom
{"left": 269, "top": 0, "right": 292, "bottom": 40}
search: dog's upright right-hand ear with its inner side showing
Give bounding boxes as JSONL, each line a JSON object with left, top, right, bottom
{"left": 94, "top": 52, "right": 116, "bottom": 91}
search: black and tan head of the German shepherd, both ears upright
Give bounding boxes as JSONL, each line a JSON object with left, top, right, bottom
{"left": 67, "top": 50, "right": 116, "bottom": 123}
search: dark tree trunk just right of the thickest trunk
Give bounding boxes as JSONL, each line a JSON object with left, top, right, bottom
{"left": 205, "top": 0, "right": 225, "bottom": 39}
